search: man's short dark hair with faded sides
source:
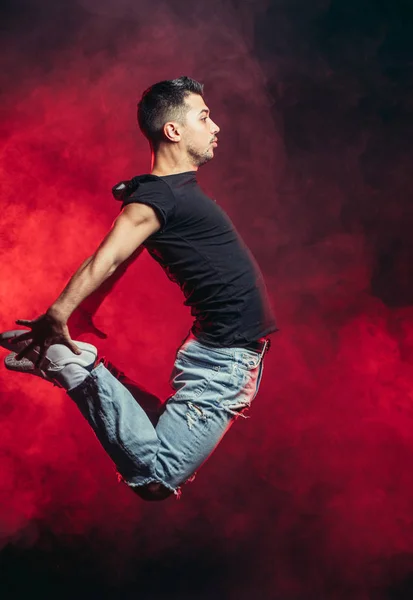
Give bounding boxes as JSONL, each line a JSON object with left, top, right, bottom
{"left": 138, "top": 77, "right": 204, "bottom": 145}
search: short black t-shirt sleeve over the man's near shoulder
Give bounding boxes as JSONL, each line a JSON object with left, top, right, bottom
{"left": 122, "top": 178, "right": 175, "bottom": 233}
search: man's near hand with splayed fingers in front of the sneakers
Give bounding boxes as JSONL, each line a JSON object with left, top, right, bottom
{"left": 12, "top": 313, "right": 81, "bottom": 368}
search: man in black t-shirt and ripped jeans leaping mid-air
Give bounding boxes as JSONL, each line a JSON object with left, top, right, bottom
{"left": 0, "top": 77, "right": 276, "bottom": 500}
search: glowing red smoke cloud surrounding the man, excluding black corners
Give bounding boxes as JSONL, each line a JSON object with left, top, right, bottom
{"left": 0, "top": 1, "right": 413, "bottom": 600}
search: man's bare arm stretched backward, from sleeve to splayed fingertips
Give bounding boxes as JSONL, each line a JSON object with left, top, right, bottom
{"left": 11, "top": 203, "right": 161, "bottom": 365}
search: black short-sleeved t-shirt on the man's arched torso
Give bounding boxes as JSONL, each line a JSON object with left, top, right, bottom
{"left": 117, "top": 171, "right": 277, "bottom": 347}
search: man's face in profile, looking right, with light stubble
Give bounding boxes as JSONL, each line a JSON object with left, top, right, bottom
{"left": 179, "top": 94, "right": 220, "bottom": 167}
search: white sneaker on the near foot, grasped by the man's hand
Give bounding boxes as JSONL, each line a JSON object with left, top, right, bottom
{"left": 0, "top": 340, "right": 98, "bottom": 387}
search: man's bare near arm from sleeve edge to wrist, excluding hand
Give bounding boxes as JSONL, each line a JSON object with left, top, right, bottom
{"left": 46, "top": 203, "right": 161, "bottom": 322}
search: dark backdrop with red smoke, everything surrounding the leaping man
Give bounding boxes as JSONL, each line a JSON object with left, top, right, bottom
{"left": 0, "top": 0, "right": 413, "bottom": 600}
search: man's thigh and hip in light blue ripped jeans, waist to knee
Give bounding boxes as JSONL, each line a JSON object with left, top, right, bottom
{"left": 152, "top": 342, "right": 263, "bottom": 486}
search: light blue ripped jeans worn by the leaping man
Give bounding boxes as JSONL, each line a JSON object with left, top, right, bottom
{"left": 69, "top": 334, "right": 267, "bottom": 497}
